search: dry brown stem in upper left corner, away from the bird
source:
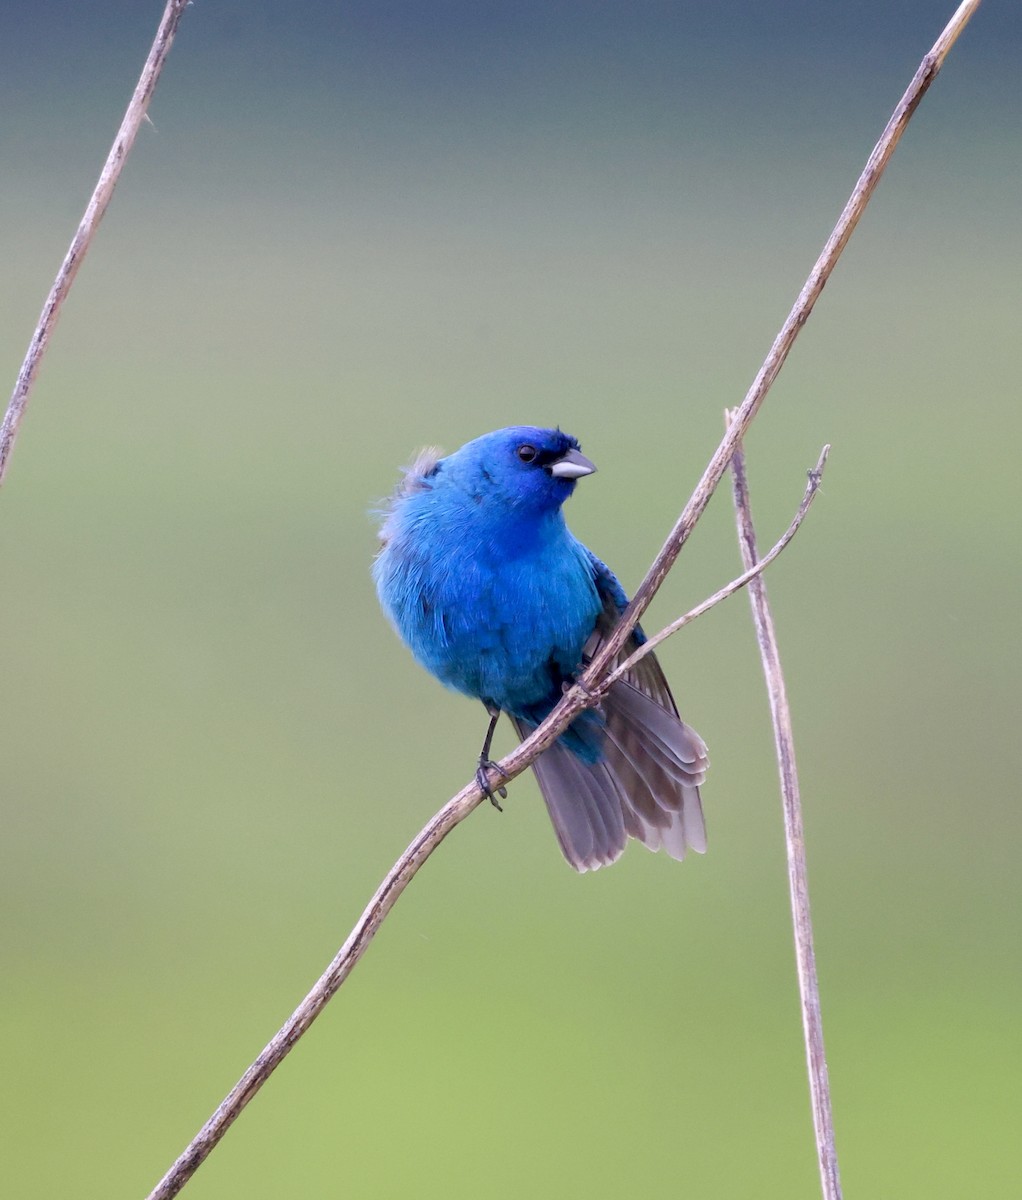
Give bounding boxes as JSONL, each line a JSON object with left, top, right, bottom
{"left": 0, "top": 0, "right": 191, "bottom": 484}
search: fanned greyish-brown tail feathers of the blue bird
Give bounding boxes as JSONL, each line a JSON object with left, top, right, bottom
{"left": 512, "top": 679, "right": 709, "bottom": 871}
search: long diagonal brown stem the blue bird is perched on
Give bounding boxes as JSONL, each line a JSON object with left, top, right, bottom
{"left": 149, "top": 0, "right": 979, "bottom": 1200}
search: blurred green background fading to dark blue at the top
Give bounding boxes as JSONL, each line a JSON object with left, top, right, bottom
{"left": 0, "top": 0, "right": 1022, "bottom": 1200}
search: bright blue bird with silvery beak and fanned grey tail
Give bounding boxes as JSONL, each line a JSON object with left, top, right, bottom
{"left": 373, "top": 426, "right": 708, "bottom": 871}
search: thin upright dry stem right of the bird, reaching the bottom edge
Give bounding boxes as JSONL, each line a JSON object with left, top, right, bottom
{"left": 726, "top": 413, "right": 841, "bottom": 1200}
